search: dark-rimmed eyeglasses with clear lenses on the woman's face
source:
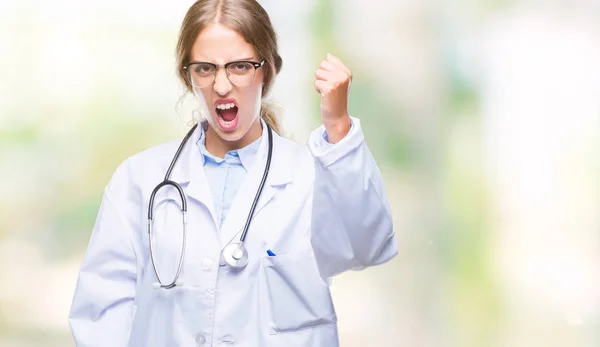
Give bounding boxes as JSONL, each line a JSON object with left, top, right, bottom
{"left": 183, "top": 60, "right": 265, "bottom": 88}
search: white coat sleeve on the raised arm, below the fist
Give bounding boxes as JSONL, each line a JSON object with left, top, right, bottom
{"left": 308, "top": 118, "right": 398, "bottom": 278}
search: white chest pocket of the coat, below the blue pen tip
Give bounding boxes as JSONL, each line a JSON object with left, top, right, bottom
{"left": 261, "top": 251, "right": 337, "bottom": 335}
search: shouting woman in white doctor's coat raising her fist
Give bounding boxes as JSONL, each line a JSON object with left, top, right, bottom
{"left": 70, "top": 0, "right": 397, "bottom": 347}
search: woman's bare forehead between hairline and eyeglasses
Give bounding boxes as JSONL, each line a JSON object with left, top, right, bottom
{"left": 191, "top": 23, "right": 255, "bottom": 64}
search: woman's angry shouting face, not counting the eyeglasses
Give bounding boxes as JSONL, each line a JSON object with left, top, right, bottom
{"left": 191, "top": 24, "right": 264, "bottom": 148}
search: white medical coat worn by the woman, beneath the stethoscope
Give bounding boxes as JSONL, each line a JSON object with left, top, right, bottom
{"left": 69, "top": 118, "right": 397, "bottom": 347}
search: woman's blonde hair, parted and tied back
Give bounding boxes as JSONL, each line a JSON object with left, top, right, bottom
{"left": 176, "top": 0, "right": 283, "bottom": 134}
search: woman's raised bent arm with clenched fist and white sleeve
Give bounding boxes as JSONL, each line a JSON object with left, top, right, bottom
{"left": 308, "top": 54, "right": 398, "bottom": 278}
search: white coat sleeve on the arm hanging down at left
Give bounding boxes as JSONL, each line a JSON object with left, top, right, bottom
{"left": 69, "top": 164, "right": 136, "bottom": 347}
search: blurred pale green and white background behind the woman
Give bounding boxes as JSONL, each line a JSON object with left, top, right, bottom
{"left": 0, "top": 0, "right": 600, "bottom": 347}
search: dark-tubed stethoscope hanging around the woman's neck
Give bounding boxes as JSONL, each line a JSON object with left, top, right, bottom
{"left": 148, "top": 123, "right": 273, "bottom": 289}
